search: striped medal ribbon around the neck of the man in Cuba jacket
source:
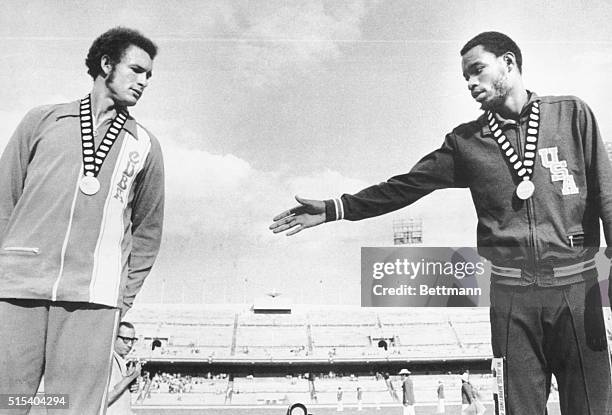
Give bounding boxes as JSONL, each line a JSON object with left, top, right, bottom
{"left": 80, "top": 95, "right": 128, "bottom": 177}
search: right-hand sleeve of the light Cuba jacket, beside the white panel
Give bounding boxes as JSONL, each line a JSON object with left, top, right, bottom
{"left": 121, "top": 137, "right": 164, "bottom": 316}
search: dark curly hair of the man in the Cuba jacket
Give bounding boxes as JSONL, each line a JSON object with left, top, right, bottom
{"left": 85, "top": 27, "right": 157, "bottom": 79}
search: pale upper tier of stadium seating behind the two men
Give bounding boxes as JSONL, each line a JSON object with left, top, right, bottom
{"left": 128, "top": 304, "right": 491, "bottom": 359}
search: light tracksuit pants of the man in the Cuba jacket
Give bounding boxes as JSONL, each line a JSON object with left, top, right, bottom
{"left": 0, "top": 299, "right": 119, "bottom": 415}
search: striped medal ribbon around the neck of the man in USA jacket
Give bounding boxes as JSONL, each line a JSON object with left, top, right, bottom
{"left": 486, "top": 101, "right": 540, "bottom": 180}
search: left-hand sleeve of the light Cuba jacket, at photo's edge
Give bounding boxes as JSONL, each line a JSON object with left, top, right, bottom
{"left": 0, "top": 108, "right": 41, "bottom": 243}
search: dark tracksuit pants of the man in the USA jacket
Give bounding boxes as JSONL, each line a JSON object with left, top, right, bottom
{"left": 491, "top": 278, "right": 612, "bottom": 415}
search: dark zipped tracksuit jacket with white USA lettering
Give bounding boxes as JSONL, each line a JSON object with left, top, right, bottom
{"left": 325, "top": 93, "right": 612, "bottom": 286}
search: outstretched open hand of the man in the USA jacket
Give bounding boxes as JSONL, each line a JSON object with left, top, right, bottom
{"left": 270, "top": 196, "right": 325, "bottom": 236}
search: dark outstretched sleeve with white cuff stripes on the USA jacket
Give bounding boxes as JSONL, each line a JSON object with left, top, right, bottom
{"left": 325, "top": 133, "right": 467, "bottom": 221}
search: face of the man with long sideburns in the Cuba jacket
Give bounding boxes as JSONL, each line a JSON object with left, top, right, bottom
{"left": 105, "top": 45, "right": 153, "bottom": 107}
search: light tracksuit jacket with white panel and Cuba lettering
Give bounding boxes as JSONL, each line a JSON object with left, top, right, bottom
{"left": 0, "top": 101, "right": 164, "bottom": 311}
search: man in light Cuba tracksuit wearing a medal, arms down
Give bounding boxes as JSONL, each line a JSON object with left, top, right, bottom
{"left": 0, "top": 28, "right": 164, "bottom": 415}
